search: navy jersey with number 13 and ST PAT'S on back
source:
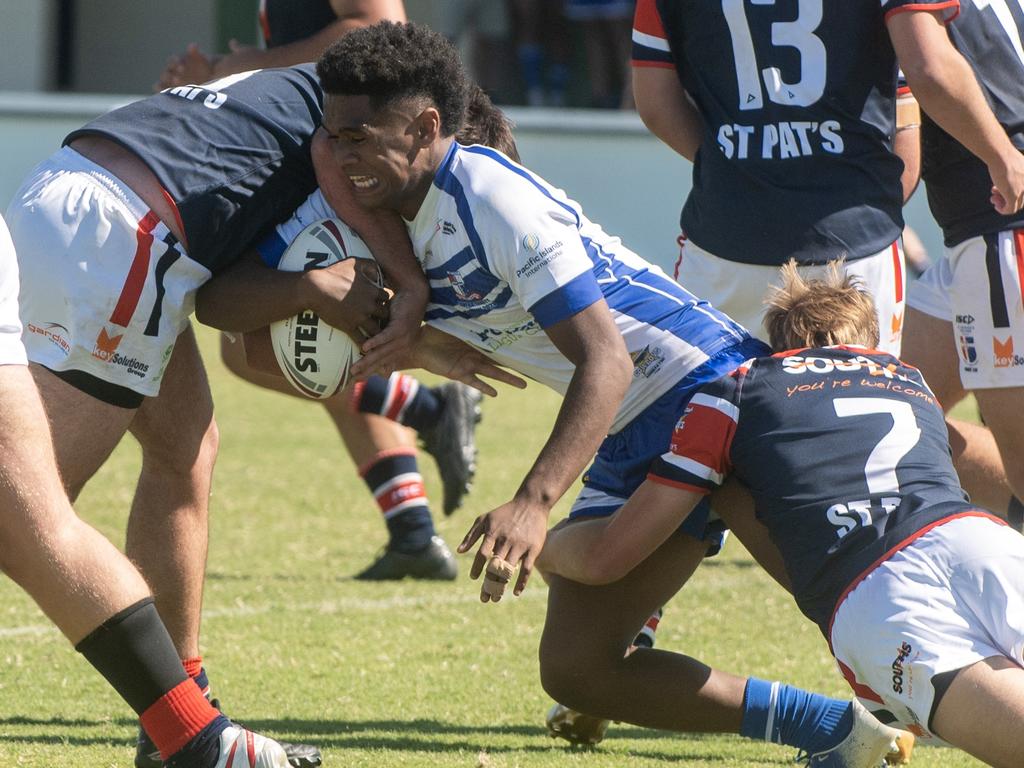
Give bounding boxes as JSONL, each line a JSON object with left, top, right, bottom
{"left": 633, "top": 0, "right": 957, "bottom": 265}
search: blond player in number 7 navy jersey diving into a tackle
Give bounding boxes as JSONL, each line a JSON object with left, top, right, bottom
{"left": 539, "top": 263, "right": 1024, "bottom": 766}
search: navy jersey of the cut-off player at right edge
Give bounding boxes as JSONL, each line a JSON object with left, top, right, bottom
{"left": 921, "top": 0, "right": 1024, "bottom": 247}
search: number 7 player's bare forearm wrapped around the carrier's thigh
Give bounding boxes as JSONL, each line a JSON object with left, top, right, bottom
{"left": 537, "top": 480, "right": 705, "bottom": 585}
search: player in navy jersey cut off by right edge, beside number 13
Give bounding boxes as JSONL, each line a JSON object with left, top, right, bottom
{"left": 904, "top": 0, "right": 1024, "bottom": 527}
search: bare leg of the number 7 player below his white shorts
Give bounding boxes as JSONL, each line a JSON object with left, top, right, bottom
{"left": 932, "top": 656, "right": 1024, "bottom": 768}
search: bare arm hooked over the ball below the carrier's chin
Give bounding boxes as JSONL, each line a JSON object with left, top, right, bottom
{"left": 311, "top": 129, "right": 429, "bottom": 376}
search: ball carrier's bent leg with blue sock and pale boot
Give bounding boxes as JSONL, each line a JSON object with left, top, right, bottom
{"left": 540, "top": 534, "right": 900, "bottom": 767}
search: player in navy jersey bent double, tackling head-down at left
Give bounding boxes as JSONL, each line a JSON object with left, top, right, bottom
{"left": 7, "top": 66, "right": 425, "bottom": 759}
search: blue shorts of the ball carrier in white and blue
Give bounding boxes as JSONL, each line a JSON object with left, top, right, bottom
{"left": 569, "top": 339, "right": 771, "bottom": 551}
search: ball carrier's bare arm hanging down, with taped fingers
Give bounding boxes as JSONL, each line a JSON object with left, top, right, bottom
{"left": 459, "top": 299, "right": 633, "bottom": 595}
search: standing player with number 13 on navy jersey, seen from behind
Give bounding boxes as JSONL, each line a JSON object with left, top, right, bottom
{"left": 633, "top": 0, "right": 1024, "bottom": 353}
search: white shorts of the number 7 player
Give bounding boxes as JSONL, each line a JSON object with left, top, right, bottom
{"left": 831, "top": 516, "right": 1024, "bottom": 743}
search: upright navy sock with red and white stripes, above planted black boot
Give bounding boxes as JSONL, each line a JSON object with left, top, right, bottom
{"left": 362, "top": 452, "right": 435, "bottom": 554}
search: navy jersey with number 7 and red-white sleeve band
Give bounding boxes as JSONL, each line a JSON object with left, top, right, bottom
{"left": 649, "top": 347, "right": 967, "bottom": 637}
